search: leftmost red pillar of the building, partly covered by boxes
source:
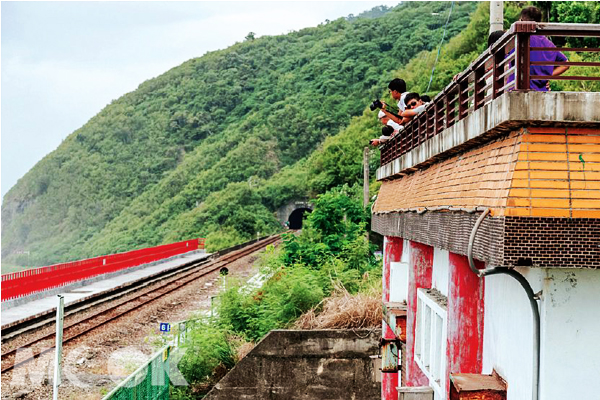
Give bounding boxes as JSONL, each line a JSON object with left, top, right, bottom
{"left": 381, "top": 236, "right": 403, "bottom": 400}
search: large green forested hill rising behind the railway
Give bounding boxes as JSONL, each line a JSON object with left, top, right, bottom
{"left": 2, "top": 2, "right": 482, "bottom": 265}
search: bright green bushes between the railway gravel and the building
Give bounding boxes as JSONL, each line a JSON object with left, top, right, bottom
{"left": 172, "top": 186, "right": 381, "bottom": 399}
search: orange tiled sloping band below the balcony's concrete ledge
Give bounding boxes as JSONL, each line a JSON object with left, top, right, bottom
{"left": 373, "top": 127, "right": 600, "bottom": 218}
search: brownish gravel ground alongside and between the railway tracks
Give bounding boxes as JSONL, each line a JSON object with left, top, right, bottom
{"left": 2, "top": 250, "right": 263, "bottom": 400}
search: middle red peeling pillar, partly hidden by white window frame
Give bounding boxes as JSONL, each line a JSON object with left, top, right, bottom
{"left": 406, "top": 241, "right": 433, "bottom": 386}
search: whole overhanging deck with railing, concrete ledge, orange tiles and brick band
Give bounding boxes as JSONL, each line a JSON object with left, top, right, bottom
{"left": 372, "top": 22, "right": 600, "bottom": 268}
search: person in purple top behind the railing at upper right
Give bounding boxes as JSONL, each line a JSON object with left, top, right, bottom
{"left": 509, "top": 7, "right": 569, "bottom": 92}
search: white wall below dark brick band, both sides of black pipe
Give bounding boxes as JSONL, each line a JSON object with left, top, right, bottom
{"left": 483, "top": 268, "right": 600, "bottom": 400}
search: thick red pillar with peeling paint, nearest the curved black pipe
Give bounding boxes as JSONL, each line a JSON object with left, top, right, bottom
{"left": 446, "top": 253, "right": 485, "bottom": 393}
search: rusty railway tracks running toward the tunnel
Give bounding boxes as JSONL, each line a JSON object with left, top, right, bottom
{"left": 2, "top": 235, "right": 280, "bottom": 374}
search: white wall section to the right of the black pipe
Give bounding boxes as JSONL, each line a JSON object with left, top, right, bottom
{"left": 540, "top": 268, "right": 600, "bottom": 400}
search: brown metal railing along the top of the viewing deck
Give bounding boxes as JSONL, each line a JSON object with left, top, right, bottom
{"left": 381, "top": 22, "right": 600, "bottom": 165}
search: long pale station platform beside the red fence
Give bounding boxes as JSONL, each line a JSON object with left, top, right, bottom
{"left": 1, "top": 250, "right": 211, "bottom": 328}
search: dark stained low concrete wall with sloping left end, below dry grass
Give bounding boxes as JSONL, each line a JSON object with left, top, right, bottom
{"left": 205, "top": 329, "right": 381, "bottom": 400}
